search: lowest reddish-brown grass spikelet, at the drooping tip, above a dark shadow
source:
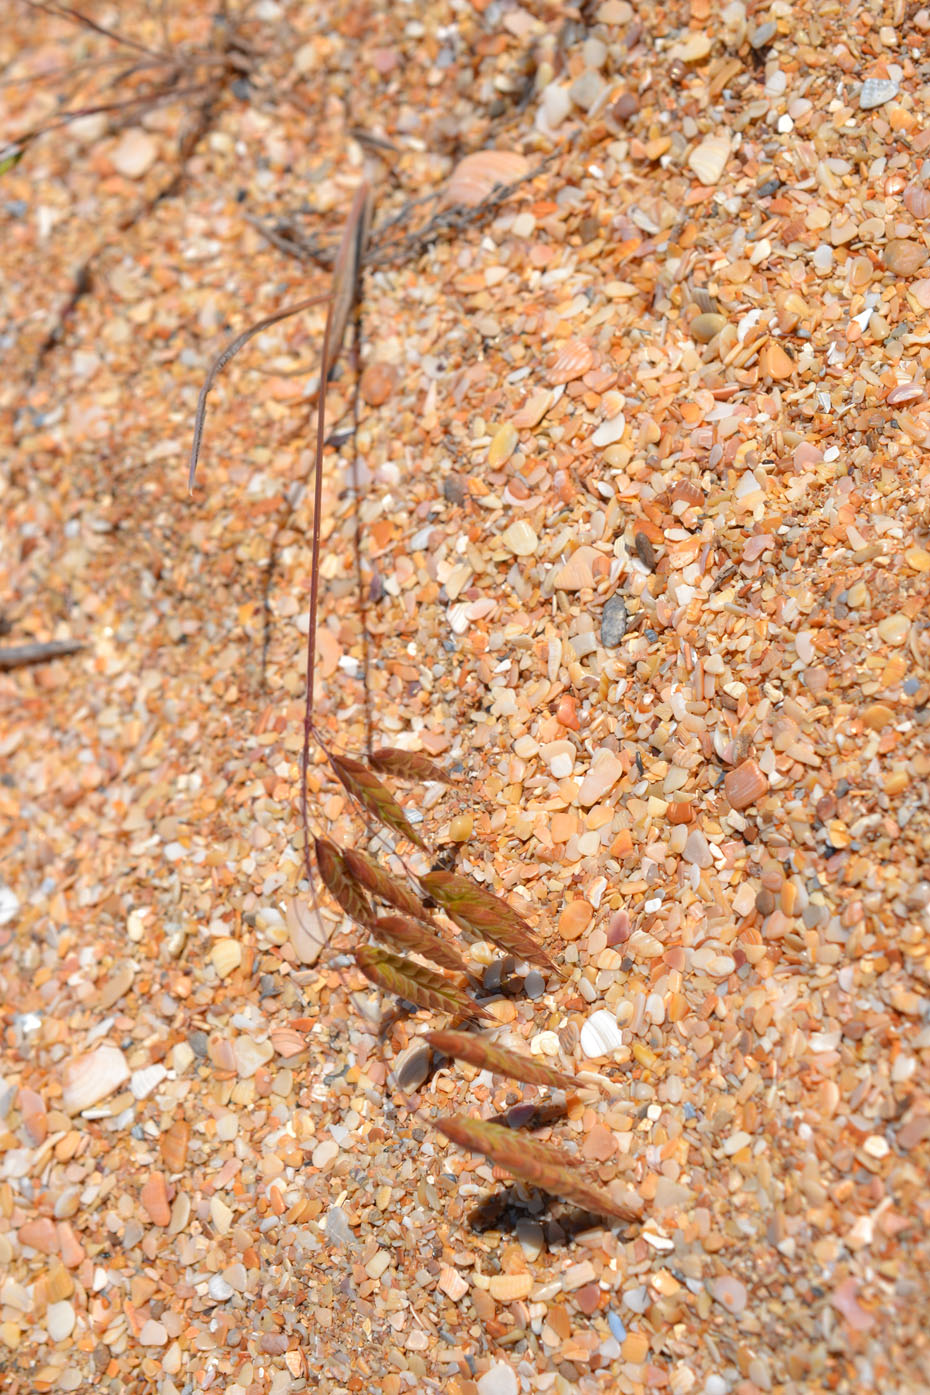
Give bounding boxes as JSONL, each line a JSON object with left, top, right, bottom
{"left": 434, "top": 1115, "right": 640, "bottom": 1221}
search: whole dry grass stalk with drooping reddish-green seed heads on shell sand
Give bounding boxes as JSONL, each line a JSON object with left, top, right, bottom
{"left": 190, "top": 183, "right": 639, "bottom": 1221}
